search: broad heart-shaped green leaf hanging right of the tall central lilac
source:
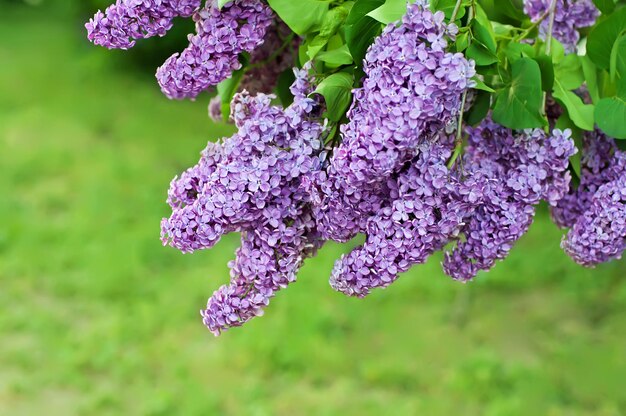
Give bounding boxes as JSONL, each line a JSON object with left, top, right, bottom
{"left": 493, "top": 58, "right": 547, "bottom": 129}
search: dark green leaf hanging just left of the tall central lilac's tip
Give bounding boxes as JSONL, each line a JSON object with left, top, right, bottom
{"left": 345, "top": 0, "right": 384, "bottom": 64}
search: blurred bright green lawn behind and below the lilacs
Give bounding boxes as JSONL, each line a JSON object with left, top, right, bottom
{"left": 0, "top": 4, "right": 626, "bottom": 416}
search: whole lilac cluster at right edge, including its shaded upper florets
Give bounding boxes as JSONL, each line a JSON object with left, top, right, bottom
{"left": 552, "top": 132, "right": 626, "bottom": 266}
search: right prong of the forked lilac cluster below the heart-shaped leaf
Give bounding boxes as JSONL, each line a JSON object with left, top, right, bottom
{"left": 443, "top": 119, "right": 576, "bottom": 281}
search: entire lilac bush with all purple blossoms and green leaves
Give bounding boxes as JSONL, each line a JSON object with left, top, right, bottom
{"left": 86, "top": 0, "right": 626, "bottom": 335}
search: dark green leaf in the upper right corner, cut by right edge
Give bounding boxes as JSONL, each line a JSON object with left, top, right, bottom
{"left": 587, "top": 7, "right": 626, "bottom": 70}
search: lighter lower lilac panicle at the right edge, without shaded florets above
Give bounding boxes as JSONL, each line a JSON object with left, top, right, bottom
{"left": 561, "top": 175, "right": 626, "bottom": 267}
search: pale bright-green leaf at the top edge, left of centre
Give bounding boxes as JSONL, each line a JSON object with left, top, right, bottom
{"left": 267, "top": 0, "right": 330, "bottom": 36}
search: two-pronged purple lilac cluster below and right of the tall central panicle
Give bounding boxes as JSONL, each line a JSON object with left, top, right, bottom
{"left": 331, "top": 119, "right": 576, "bottom": 290}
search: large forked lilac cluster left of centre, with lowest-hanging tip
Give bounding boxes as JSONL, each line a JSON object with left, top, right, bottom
{"left": 162, "top": 70, "right": 324, "bottom": 334}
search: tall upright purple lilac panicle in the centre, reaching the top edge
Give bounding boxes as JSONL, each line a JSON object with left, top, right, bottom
{"left": 316, "top": 0, "right": 475, "bottom": 241}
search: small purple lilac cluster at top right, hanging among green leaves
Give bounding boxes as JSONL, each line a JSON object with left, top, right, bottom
{"left": 524, "top": 0, "right": 600, "bottom": 53}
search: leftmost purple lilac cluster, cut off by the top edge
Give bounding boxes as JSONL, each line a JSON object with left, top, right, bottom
{"left": 85, "top": 0, "right": 201, "bottom": 49}
